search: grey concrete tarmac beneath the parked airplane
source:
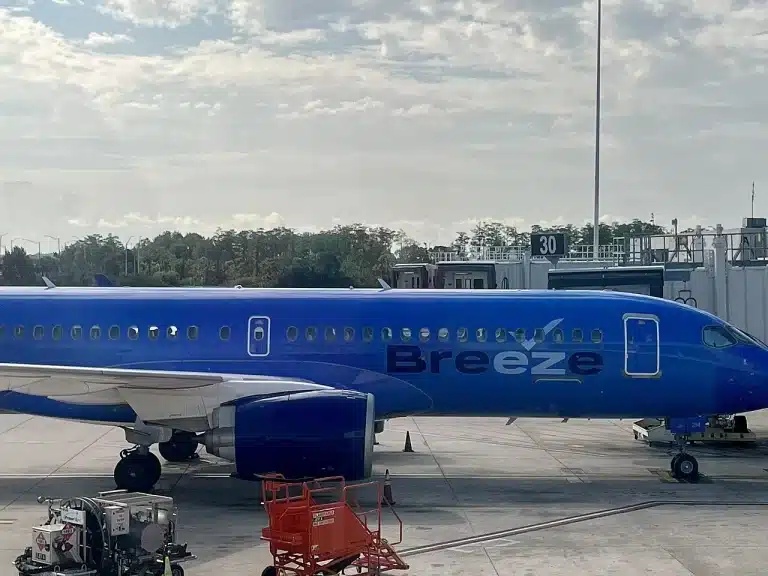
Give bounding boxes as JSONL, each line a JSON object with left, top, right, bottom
{"left": 0, "top": 412, "right": 768, "bottom": 576}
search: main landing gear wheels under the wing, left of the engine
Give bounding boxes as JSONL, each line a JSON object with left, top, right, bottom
{"left": 114, "top": 431, "right": 199, "bottom": 492}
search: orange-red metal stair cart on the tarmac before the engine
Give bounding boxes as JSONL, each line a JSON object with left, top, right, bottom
{"left": 261, "top": 476, "right": 408, "bottom": 576}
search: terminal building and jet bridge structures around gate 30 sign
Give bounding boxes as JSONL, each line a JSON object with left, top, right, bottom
{"left": 391, "top": 218, "right": 768, "bottom": 341}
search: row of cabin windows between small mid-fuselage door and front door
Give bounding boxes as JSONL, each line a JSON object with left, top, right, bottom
{"left": 284, "top": 326, "right": 603, "bottom": 344}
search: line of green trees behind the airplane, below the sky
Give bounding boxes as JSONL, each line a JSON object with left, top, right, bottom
{"left": 0, "top": 220, "right": 665, "bottom": 288}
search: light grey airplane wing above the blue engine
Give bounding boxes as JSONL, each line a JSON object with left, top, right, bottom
{"left": 0, "top": 363, "right": 330, "bottom": 431}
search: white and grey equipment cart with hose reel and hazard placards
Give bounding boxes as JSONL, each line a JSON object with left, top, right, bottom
{"left": 14, "top": 490, "right": 195, "bottom": 576}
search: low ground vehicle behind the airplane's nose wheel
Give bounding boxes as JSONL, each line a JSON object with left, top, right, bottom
{"left": 632, "top": 415, "right": 757, "bottom": 446}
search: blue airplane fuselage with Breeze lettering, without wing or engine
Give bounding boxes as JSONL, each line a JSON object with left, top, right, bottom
{"left": 0, "top": 288, "right": 768, "bottom": 424}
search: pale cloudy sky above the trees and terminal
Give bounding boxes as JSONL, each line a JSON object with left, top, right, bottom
{"left": 0, "top": 0, "right": 768, "bottom": 250}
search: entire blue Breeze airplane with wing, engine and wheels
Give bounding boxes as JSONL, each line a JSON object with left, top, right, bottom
{"left": 0, "top": 281, "right": 768, "bottom": 491}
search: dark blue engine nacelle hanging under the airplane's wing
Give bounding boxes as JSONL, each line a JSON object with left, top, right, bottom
{"left": 203, "top": 390, "right": 374, "bottom": 480}
